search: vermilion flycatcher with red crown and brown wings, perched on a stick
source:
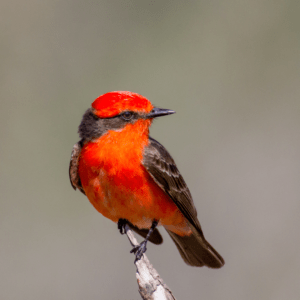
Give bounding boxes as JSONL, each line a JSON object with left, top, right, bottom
{"left": 70, "top": 91, "right": 224, "bottom": 268}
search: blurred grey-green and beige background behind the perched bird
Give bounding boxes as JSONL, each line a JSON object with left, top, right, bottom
{"left": 0, "top": 0, "right": 300, "bottom": 300}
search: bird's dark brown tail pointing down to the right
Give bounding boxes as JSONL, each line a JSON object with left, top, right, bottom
{"left": 166, "top": 225, "right": 225, "bottom": 269}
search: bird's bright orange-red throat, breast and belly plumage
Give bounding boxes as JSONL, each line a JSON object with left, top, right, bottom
{"left": 78, "top": 120, "right": 185, "bottom": 233}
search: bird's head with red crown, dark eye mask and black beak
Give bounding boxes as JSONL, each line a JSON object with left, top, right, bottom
{"left": 78, "top": 91, "right": 175, "bottom": 141}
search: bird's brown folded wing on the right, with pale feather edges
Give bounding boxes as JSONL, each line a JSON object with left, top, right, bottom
{"left": 143, "top": 137, "right": 202, "bottom": 234}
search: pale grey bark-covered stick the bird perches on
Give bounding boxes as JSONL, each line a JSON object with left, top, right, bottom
{"left": 125, "top": 225, "right": 175, "bottom": 300}
